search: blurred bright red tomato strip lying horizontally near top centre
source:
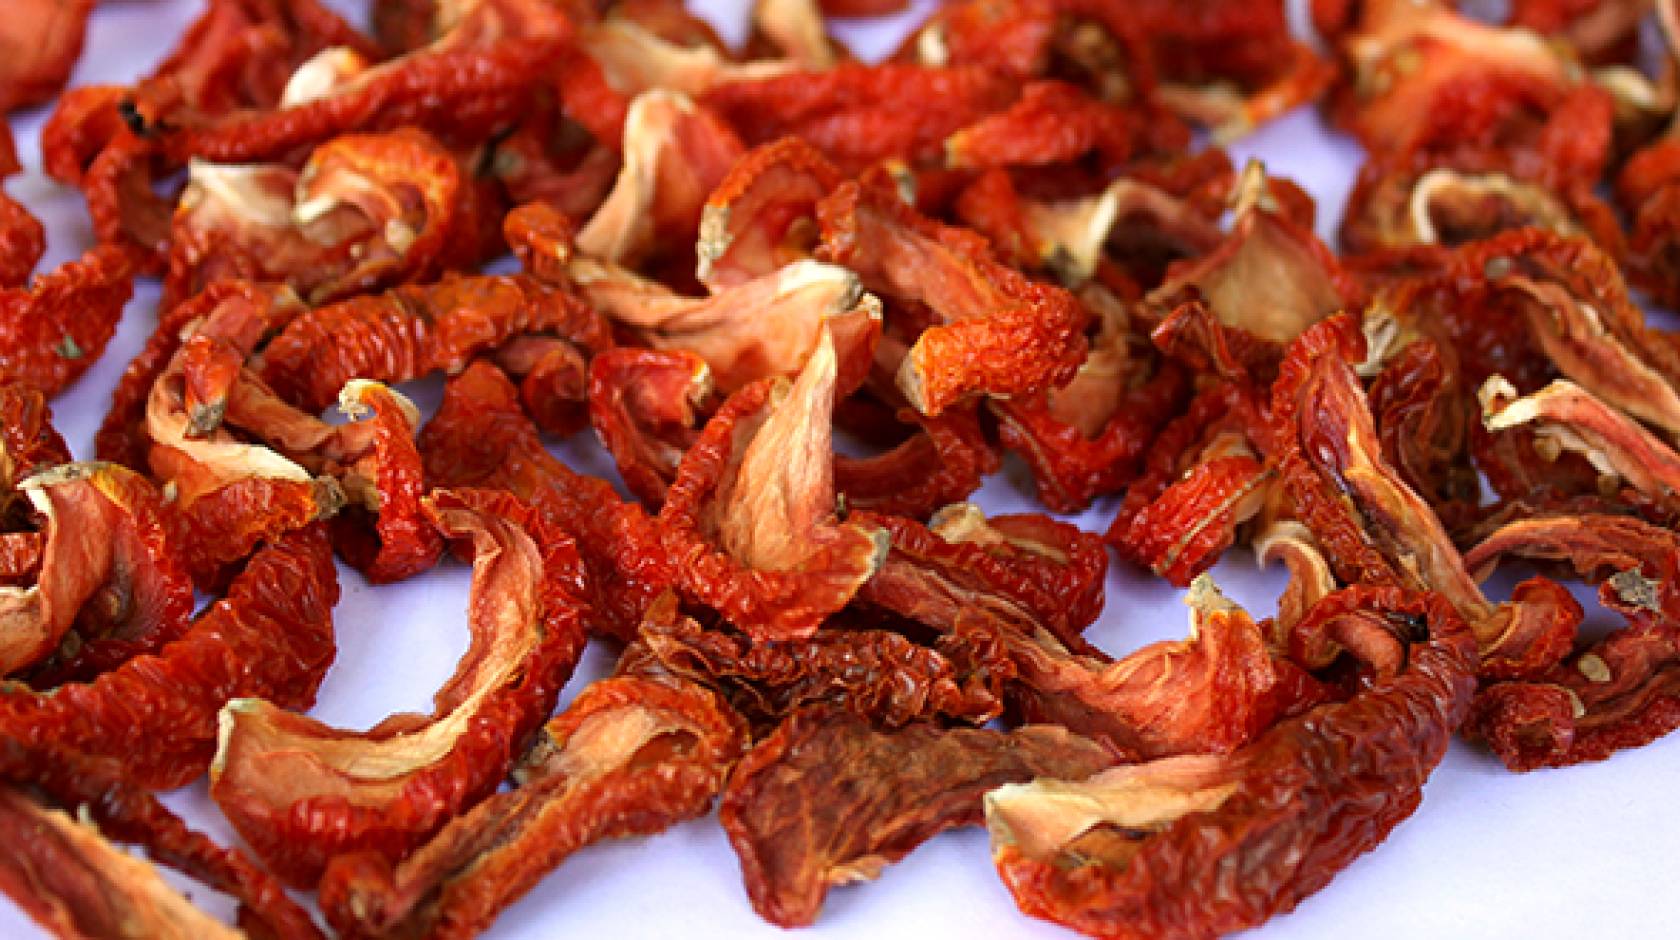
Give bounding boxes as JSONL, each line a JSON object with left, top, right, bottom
{"left": 701, "top": 64, "right": 1016, "bottom": 170}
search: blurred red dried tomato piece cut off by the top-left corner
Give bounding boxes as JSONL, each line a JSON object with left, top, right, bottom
{"left": 0, "top": 0, "right": 94, "bottom": 114}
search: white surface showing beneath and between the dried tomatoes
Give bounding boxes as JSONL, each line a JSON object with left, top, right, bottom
{"left": 0, "top": 0, "right": 1680, "bottom": 940}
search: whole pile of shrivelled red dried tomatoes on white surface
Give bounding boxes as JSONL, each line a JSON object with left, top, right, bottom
{"left": 0, "top": 0, "right": 1680, "bottom": 938}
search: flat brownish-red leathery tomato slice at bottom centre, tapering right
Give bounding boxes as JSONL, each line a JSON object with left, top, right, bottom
{"left": 717, "top": 707, "right": 1112, "bottom": 927}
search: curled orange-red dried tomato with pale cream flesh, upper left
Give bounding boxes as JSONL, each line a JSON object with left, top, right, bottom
{"left": 163, "top": 129, "right": 480, "bottom": 307}
